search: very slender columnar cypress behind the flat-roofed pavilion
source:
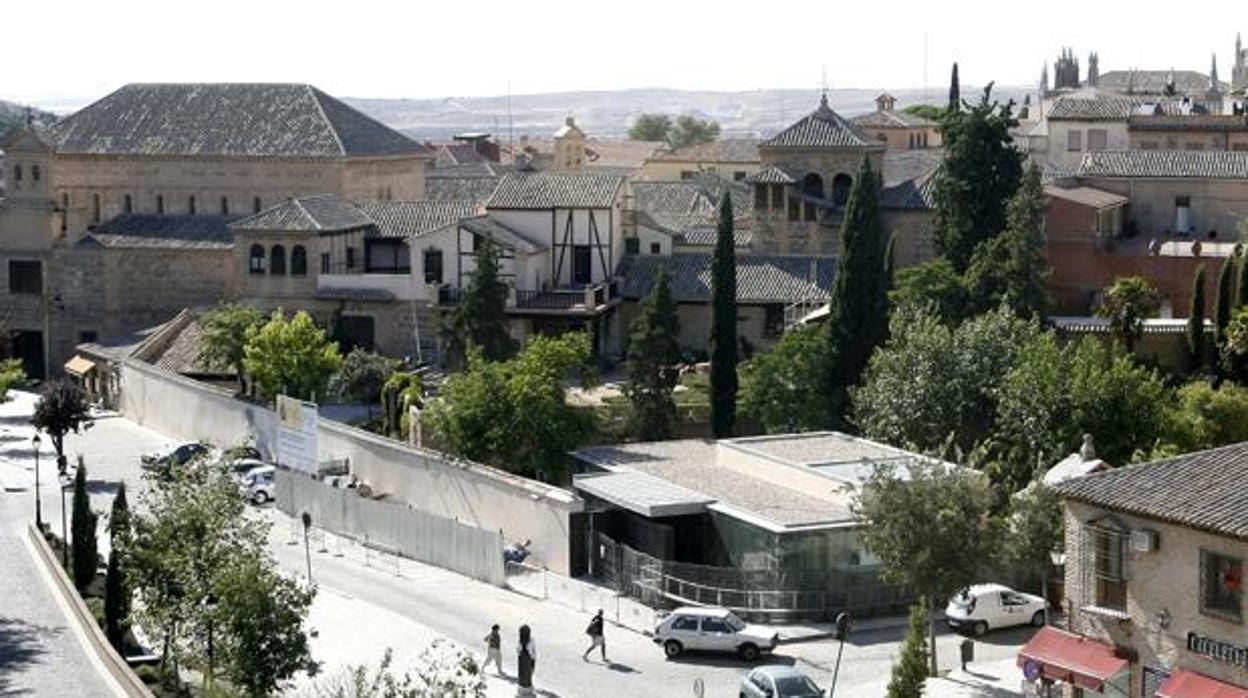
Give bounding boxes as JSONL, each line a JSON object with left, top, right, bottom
{"left": 709, "top": 192, "right": 736, "bottom": 438}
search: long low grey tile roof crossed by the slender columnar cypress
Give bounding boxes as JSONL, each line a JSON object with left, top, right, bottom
{"left": 619, "top": 252, "right": 836, "bottom": 303}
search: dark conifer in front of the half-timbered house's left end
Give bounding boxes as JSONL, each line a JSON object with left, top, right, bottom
{"left": 443, "top": 240, "right": 517, "bottom": 367}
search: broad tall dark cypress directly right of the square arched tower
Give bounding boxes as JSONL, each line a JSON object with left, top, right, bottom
{"left": 824, "top": 157, "right": 889, "bottom": 431}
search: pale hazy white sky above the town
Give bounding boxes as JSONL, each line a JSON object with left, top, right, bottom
{"left": 0, "top": 0, "right": 1248, "bottom": 105}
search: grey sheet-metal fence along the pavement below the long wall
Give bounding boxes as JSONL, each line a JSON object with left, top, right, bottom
{"left": 273, "top": 469, "right": 507, "bottom": 587}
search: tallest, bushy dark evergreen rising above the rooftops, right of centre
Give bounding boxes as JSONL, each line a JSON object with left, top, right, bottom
{"left": 935, "top": 85, "right": 1022, "bottom": 273}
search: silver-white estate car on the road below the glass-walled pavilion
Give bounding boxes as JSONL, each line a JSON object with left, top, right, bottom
{"left": 654, "top": 607, "right": 780, "bottom": 662}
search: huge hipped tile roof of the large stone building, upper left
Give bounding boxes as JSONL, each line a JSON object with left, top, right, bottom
{"left": 49, "top": 84, "right": 424, "bottom": 157}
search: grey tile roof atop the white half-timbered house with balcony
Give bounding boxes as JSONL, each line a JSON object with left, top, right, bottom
{"left": 485, "top": 172, "right": 625, "bottom": 210}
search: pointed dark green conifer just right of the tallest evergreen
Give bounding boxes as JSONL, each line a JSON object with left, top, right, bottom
{"left": 966, "top": 162, "right": 1052, "bottom": 321}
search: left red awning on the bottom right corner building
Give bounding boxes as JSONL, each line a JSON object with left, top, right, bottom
{"left": 1018, "top": 626, "right": 1127, "bottom": 692}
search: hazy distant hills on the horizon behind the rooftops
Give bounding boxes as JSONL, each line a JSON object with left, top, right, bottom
{"left": 346, "top": 86, "right": 1027, "bottom": 140}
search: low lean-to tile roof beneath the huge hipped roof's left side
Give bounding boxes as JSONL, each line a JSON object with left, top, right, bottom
{"left": 84, "top": 214, "right": 235, "bottom": 250}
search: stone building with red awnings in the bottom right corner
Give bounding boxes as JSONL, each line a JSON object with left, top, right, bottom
{"left": 1018, "top": 443, "right": 1248, "bottom": 698}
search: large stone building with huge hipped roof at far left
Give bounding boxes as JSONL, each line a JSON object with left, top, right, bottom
{"left": 0, "top": 84, "right": 427, "bottom": 376}
